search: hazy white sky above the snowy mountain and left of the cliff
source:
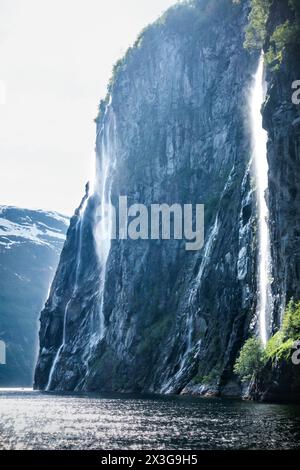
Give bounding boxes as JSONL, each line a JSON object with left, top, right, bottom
{"left": 0, "top": 0, "right": 176, "bottom": 214}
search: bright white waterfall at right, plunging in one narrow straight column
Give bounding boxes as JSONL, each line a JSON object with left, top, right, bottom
{"left": 250, "top": 54, "right": 273, "bottom": 345}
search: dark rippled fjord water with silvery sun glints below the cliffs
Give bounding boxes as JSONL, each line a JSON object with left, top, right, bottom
{"left": 0, "top": 390, "right": 300, "bottom": 450}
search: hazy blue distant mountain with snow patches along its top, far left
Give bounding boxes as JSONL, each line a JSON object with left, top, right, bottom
{"left": 0, "top": 206, "right": 69, "bottom": 387}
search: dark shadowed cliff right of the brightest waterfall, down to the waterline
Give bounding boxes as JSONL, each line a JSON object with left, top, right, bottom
{"left": 252, "top": 2, "right": 300, "bottom": 401}
